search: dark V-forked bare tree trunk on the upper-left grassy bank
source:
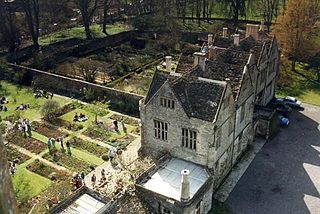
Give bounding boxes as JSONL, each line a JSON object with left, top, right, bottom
{"left": 75, "top": 0, "right": 98, "bottom": 40}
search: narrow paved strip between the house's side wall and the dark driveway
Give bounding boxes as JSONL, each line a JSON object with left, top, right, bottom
{"left": 214, "top": 139, "right": 266, "bottom": 202}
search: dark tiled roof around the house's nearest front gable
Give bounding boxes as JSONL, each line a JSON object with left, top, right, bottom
{"left": 145, "top": 67, "right": 226, "bottom": 122}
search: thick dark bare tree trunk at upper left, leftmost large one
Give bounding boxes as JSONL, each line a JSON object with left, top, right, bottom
{"left": 21, "top": 0, "right": 39, "bottom": 49}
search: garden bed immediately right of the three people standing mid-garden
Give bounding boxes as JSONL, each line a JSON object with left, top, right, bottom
{"left": 70, "top": 138, "right": 108, "bottom": 157}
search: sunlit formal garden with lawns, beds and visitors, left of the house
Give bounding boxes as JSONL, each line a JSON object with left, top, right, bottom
{"left": 0, "top": 81, "right": 139, "bottom": 213}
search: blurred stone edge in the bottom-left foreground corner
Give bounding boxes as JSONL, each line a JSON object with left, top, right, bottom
{"left": 0, "top": 134, "right": 18, "bottom": 214}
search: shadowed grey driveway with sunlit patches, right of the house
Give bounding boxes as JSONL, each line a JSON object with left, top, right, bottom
{"left": 226, "top": 104, "right": 320, "bottom": 214}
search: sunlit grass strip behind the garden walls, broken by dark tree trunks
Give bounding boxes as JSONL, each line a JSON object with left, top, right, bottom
{"left": 39, "top": 23, "right": 131, "bottom": 45}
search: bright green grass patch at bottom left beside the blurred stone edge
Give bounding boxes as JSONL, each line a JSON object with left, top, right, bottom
{"left": 12, "top": 164, "right": 51, "bottom": 202}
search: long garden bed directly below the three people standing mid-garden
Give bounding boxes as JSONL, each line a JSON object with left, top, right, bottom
{"left": 43, "top": 149, "right": 95, "bottom": 173}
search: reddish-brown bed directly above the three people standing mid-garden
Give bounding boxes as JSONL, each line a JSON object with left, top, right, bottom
{"left": 31, "top": 121, "right": 68, "bottom": 138}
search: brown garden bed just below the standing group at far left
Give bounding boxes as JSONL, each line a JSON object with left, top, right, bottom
{"left": 6, "top": 131, "right": 47, "bottom": 154}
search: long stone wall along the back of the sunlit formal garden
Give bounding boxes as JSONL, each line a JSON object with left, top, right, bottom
{"left": 6, "top": 64, "right": 144, "bottom": 117}
